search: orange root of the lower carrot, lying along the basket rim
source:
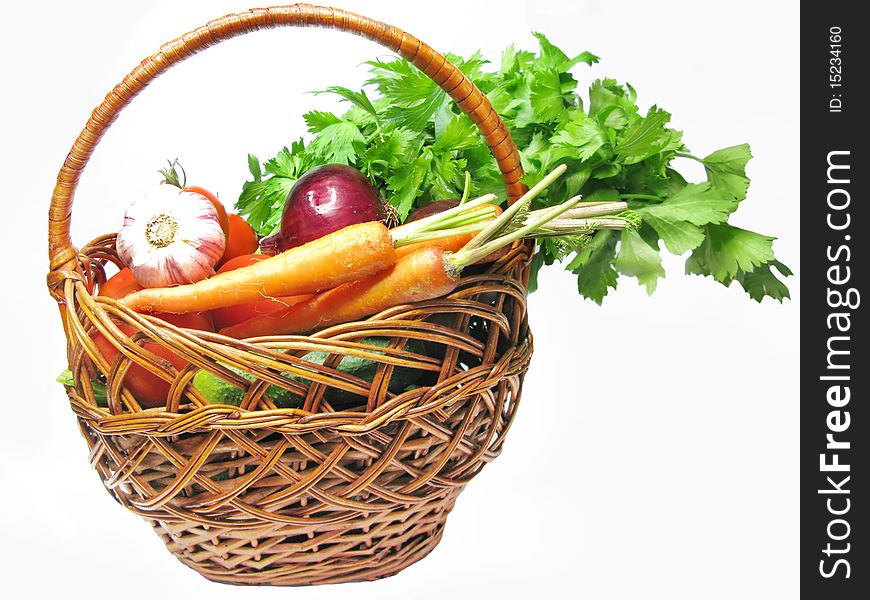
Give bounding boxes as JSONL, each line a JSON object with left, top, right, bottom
{"left": 221, "top": 247, "right": 461, "bottom": 338}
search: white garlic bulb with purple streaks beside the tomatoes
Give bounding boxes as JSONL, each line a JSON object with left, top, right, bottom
{"left": 115, "top": 185, "right": 226, "bottom": 287}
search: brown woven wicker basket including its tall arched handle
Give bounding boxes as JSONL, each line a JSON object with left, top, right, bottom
{"left": 48, "top": 5, "right": 532, "bottom": 585}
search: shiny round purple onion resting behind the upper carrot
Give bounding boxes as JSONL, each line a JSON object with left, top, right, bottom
{"left": 260, "top": 165, "right": 386, "bottom": 254}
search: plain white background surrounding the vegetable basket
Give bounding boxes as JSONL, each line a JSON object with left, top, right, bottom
{"left": 0, "top": 0, "right": 800, "bottom": 600}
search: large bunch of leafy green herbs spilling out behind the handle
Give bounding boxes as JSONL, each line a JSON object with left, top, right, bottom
{"left": 236, "top": 33, "right": 791, "bottom": 304}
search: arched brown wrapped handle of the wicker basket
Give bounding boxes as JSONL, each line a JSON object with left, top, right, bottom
{"left": 48, "top": 4, "right": 526, "bottom": 282}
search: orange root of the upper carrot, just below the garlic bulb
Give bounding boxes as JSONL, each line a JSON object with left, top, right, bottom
{"left": 122, "top": 221, "right": 396, "bottom": 313}
